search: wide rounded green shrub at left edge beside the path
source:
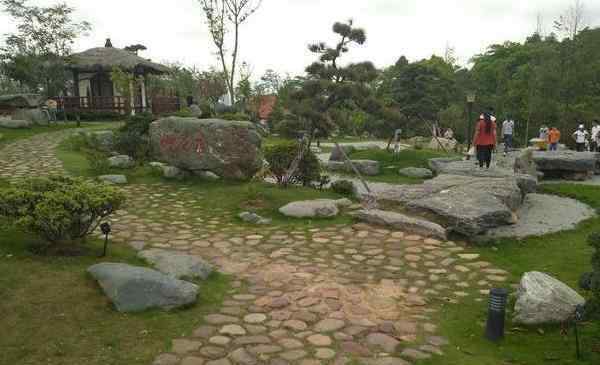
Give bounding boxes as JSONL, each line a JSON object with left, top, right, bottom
{"left": 0, "top": 176, "right": 125, "bottom": 244}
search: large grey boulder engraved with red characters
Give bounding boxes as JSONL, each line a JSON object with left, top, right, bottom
{"left": 150, "top": 117, "right": 263, "bottom": 180}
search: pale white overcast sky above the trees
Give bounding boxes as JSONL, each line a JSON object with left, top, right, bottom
{"left": 0, "top": 0, "right": 600, "bottom": 78}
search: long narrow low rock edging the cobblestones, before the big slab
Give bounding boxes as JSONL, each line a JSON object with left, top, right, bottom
{"left": 355, "top": 209, "right": 447, "bottom": 240}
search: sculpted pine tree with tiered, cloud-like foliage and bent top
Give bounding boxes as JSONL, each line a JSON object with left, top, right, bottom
{"left": 290, "top": 21, "right": 391, "bottom": 142}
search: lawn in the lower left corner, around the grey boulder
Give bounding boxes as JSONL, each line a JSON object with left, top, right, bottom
{"left": 0, "top": 219, "right": 230, "bottom": 365}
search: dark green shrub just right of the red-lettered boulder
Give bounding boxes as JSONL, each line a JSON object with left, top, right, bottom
{"left": 265, "top": 142, "right": 321, "bottom": 186}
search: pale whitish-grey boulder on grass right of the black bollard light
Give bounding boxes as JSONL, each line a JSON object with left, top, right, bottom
{"left": 514, "top": 271, "right": 585, "bottom": 325}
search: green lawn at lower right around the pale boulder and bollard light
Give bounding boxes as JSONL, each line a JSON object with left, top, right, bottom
{"left": 419, "top": 184, "right": 600, "bottom": 365}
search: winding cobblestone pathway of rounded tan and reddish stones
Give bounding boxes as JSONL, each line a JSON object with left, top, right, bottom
{"left": 0, "top": 135, "right": 507, "bottom": 365}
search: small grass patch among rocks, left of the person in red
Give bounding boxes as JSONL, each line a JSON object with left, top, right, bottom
{"left": 350, "top": 149, "right": 448, "bottom": 184}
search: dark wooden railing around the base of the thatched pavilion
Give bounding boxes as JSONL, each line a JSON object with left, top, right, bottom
{"left": 53, "top": 96, "right": 180, "bottom": 115}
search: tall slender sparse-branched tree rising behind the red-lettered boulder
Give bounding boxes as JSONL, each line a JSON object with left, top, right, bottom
{"left": 198, "top": 0, "right": 262, "bottom": 104}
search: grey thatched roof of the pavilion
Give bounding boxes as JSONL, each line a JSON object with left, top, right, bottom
{"left": 67, "top": 47, "right": 169, "bottom": 74}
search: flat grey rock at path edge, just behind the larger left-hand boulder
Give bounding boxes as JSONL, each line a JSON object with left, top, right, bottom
{"left": 138, "top": 249, "right": 213, "bottom": 280}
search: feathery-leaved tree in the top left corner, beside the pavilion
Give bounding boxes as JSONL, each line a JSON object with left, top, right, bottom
{"left": 0, "top": 0, "right": 91, "bottom": 96}
